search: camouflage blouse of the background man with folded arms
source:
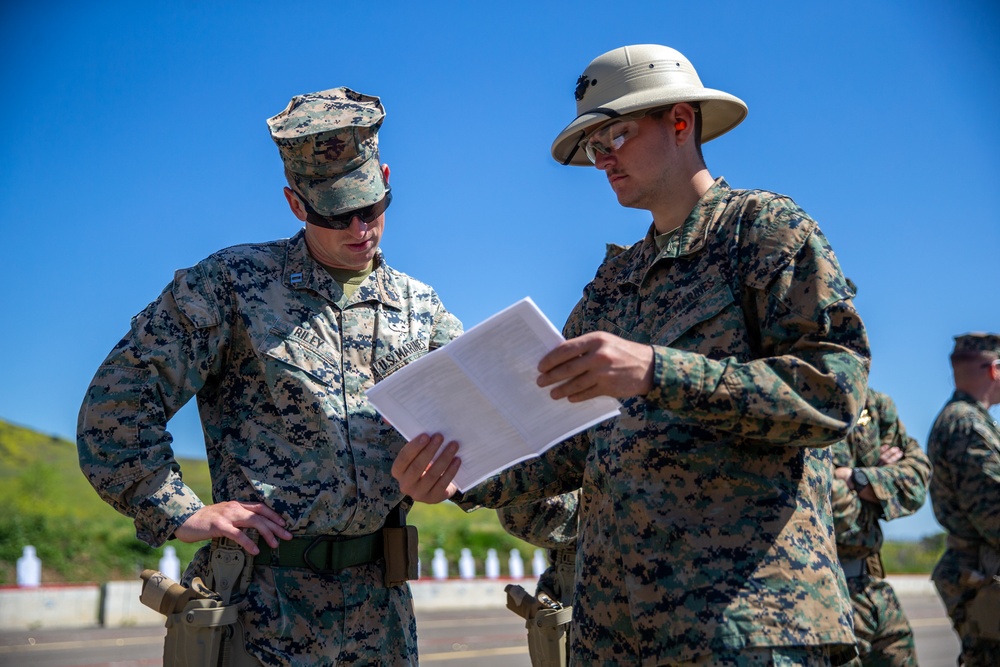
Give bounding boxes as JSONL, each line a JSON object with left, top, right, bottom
{"left": 833, "top": 389, "right": 931, "bottom": 560}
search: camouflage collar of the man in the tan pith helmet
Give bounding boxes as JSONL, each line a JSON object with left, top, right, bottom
{"left": 619, "top": 176, "right": 732, "bottom": 285}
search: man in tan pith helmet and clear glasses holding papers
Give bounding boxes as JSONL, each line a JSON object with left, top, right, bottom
{"left": 394, "top": 45, "right": 869, "bottom": 665}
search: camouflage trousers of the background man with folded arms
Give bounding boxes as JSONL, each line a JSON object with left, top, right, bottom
{"left": 847, "top": 574, "right": 917, "bottom": 667}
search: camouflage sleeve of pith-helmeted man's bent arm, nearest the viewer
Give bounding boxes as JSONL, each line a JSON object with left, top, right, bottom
{"left": 647, "top": 199, "right": 870, "bottom": 446}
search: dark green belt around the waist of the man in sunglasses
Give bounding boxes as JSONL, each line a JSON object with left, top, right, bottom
{"left": 254, "top": 530, "right": 383, "bottom": 574}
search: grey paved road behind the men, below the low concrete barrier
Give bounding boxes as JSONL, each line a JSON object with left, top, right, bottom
{"left": 0, "top": 593, "right": 958, "bottom": 667}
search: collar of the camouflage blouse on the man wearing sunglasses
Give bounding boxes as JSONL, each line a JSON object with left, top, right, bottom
{"left": 282, "top": 229, "right": 402, "bottom": 309}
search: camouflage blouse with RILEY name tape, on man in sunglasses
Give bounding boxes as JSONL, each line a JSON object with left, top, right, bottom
{"left": 78, "top": 231, "right": 461, "bottom": 664}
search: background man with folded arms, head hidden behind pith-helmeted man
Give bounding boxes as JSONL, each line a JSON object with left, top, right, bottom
{"left": 833, "top": 387, "right": 931, "bottom": 667}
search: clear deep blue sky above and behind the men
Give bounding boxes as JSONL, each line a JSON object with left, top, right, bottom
{"left": 0, "top": 0, "right": 1000, "bottom": 538}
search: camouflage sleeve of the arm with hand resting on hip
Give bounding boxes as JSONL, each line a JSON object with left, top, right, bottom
{"left": 77, "top": 265, "right": 225, "bottom": 546}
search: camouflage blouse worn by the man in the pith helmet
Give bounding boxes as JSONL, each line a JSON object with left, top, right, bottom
{"left": 457, "top": 179, "right": 869, "bottom": 665}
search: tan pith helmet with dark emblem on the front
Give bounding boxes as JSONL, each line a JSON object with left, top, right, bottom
{"left": 552, "top": 44, "right": 747, "bottom": 166}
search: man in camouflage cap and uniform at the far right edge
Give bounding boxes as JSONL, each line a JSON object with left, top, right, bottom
{"left": 927, "top": 333, "right": 1000, "bottom": 667}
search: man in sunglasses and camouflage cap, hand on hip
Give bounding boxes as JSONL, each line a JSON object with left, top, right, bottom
{"left": 78, "top": 88, "right": 462, "bottom": 666}
